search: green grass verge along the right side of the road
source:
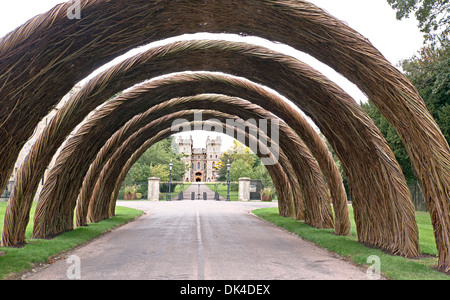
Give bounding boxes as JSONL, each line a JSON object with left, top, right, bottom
{"left": 253, "top": 206, "right": 450, "bottom": 280}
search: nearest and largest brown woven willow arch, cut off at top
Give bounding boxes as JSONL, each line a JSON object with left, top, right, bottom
{"left": 0, "top": 0, "right": 450, "bottom": 269}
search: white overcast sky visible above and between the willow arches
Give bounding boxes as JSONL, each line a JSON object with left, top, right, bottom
{"left": 0, "top": 0, "right": 423, "bottom": 149}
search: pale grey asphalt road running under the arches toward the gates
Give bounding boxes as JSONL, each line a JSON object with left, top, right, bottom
{"left": 24, "top": 200, "right": 367, "bottom": 280}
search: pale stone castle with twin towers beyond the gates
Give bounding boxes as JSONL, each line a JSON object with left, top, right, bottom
{"left": 177, "top": 136, "right": 223, "bottom": 182}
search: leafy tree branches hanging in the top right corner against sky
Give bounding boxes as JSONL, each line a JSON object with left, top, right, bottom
{"left": 387, "top": 0, "right": 450, "bottom": 44}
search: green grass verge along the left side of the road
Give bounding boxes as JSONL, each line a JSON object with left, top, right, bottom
{"left": 0, "top": 202, "right": 142, "bottom": 279}
